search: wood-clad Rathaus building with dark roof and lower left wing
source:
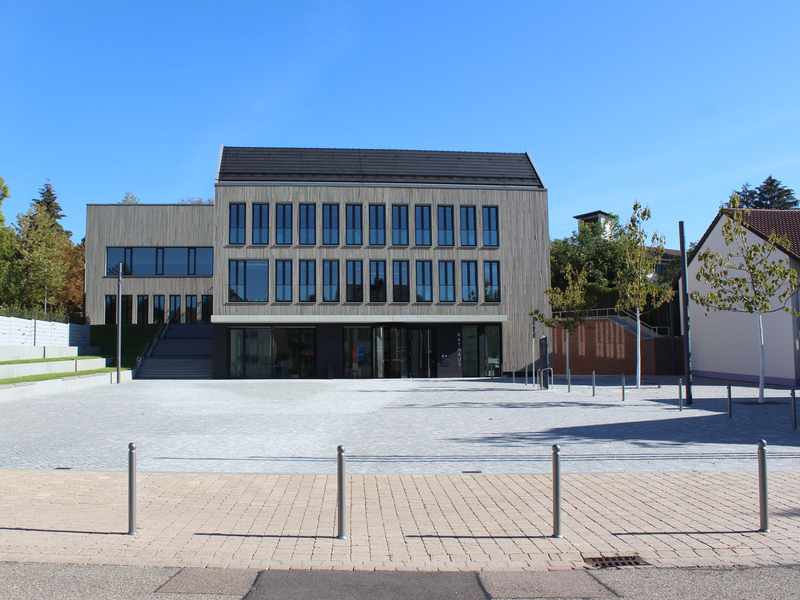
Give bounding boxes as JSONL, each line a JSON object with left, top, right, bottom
{"left": 86, "top": 147, "right": 550, "bottom": 378}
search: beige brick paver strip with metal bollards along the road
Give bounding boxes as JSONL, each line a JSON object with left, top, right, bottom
{"left": 0, "top": 471, "right": 800, "bottom": 571}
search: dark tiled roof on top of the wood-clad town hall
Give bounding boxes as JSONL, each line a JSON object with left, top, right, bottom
{"left": 217, "top": 146, "right": 544, "bottom": 189}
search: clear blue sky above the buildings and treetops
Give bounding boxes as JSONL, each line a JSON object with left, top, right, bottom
{"left": 0, "top": 0, "right": 800, "bottom": 247}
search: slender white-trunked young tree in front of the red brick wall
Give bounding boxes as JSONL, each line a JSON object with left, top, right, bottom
{"left": 617, "top": 201, "right": 673, "bottom": 388}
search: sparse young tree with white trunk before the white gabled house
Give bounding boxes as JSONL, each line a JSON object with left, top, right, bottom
{"left": 691, "top": 192, "right": 800, "bottom": 403}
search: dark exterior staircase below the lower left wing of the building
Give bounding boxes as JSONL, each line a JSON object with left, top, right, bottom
{"left": 136, "top": 324, "right": 214, "bottom": 379}
